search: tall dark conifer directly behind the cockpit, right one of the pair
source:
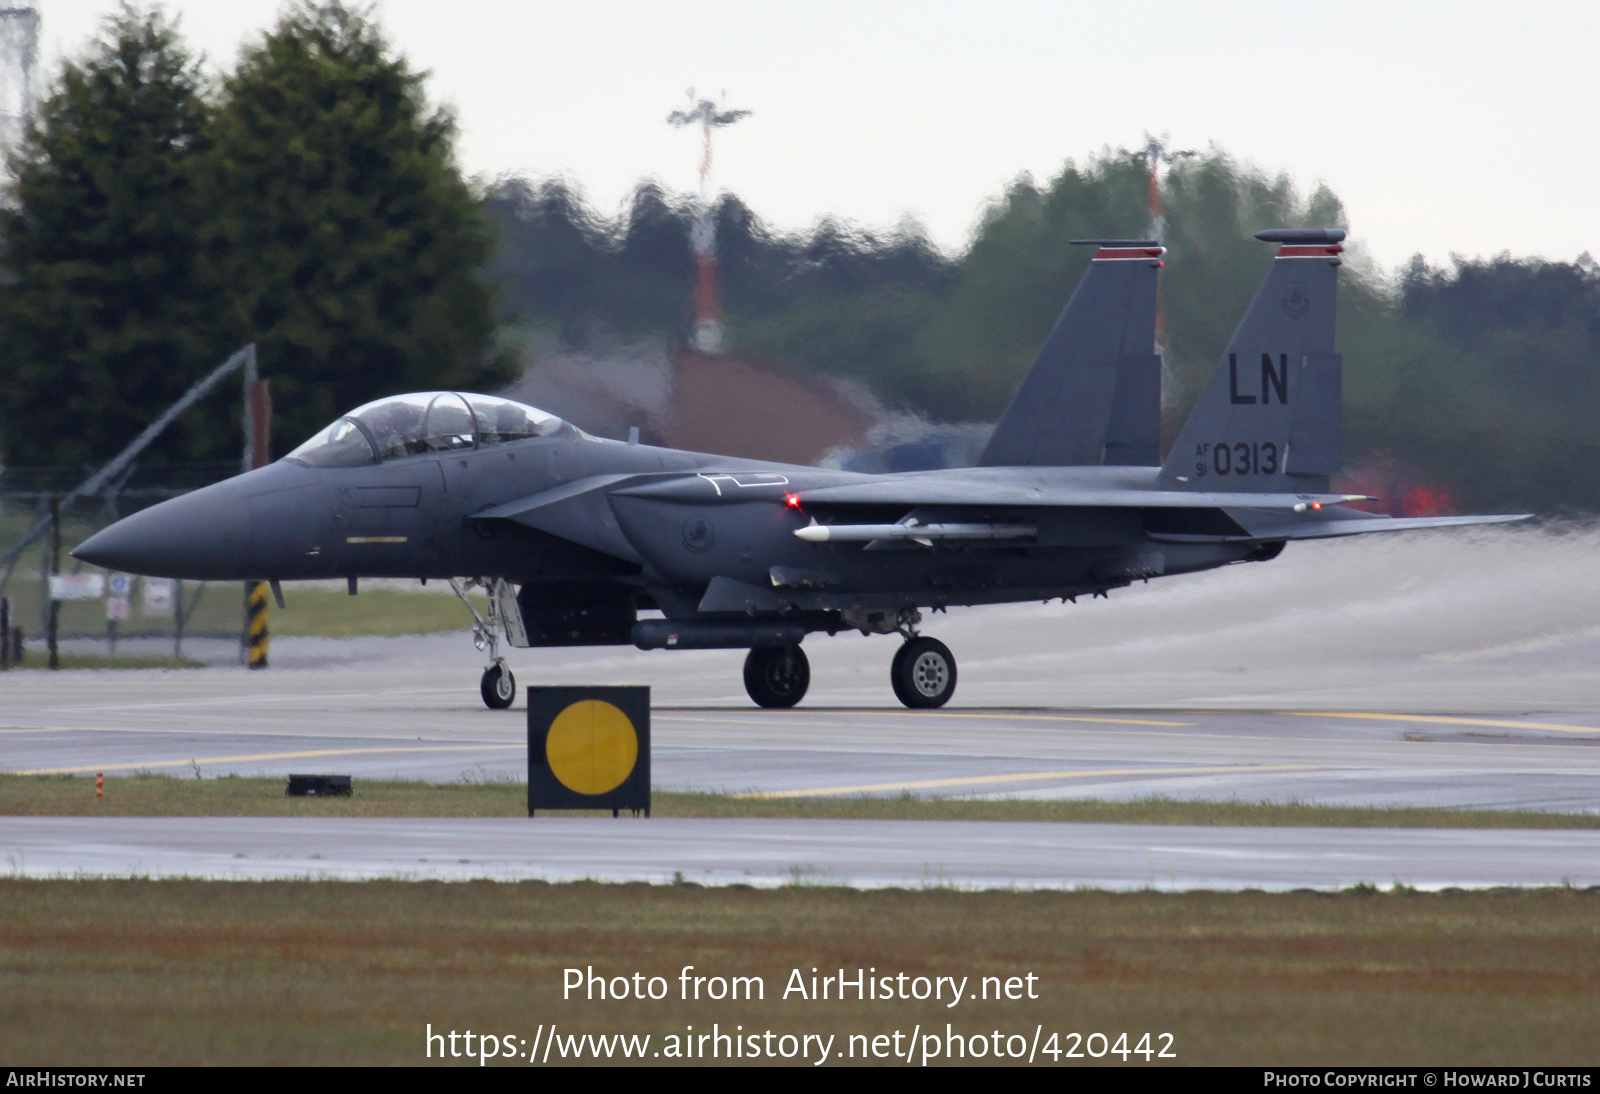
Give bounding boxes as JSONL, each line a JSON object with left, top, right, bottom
{"left": 210, "top": 3, "right": 509, "bottom": 451}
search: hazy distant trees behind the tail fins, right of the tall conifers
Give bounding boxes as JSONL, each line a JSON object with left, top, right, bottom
{"left": 486, "top": 163, "right": 1600, "bottom": 513}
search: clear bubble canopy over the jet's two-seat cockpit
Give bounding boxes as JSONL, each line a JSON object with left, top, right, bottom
{"left": 288, "top": 392, "right": 565, "bottom": 467}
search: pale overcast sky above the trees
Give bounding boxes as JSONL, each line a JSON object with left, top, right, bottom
{"left": 25, "top": 0, "right": 1600, "bottom": 266}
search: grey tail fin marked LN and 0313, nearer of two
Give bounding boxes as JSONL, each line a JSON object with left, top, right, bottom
{"left": 1162, "top": 229, "right": 1344, "bottom": 494}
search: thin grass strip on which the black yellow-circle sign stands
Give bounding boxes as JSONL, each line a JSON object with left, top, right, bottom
{"left": 0, "top": 774, "right": 1600, "bottom": 828}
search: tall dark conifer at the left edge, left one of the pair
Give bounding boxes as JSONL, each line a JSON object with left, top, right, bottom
{"left": 0, "top": 6, "right": 220, "bottom": 465}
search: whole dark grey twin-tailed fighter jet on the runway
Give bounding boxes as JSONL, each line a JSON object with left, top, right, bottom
{"left": 74, "top": 229, "right": 1517, "bottom": 709}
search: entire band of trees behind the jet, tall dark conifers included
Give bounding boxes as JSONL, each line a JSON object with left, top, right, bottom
{"left": 0, "top": 0, "right": 1600, "bottom": 513}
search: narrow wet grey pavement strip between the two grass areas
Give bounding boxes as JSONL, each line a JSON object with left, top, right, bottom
{"left": 12, "top": 817, "right": 1600, "bottom": 891}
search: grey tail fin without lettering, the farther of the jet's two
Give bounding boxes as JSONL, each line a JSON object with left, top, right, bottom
{"left": 978, "top": 240, "right": 1165, "bottom": 467}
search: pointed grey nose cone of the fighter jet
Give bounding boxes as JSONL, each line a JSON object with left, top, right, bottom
{"left": 72, "top": 481, "right": 250, "bottom": 581}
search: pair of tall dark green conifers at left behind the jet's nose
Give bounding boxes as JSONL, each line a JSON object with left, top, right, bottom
{"left": 0, "top": 2, "right": 510, "bottom": 465}
